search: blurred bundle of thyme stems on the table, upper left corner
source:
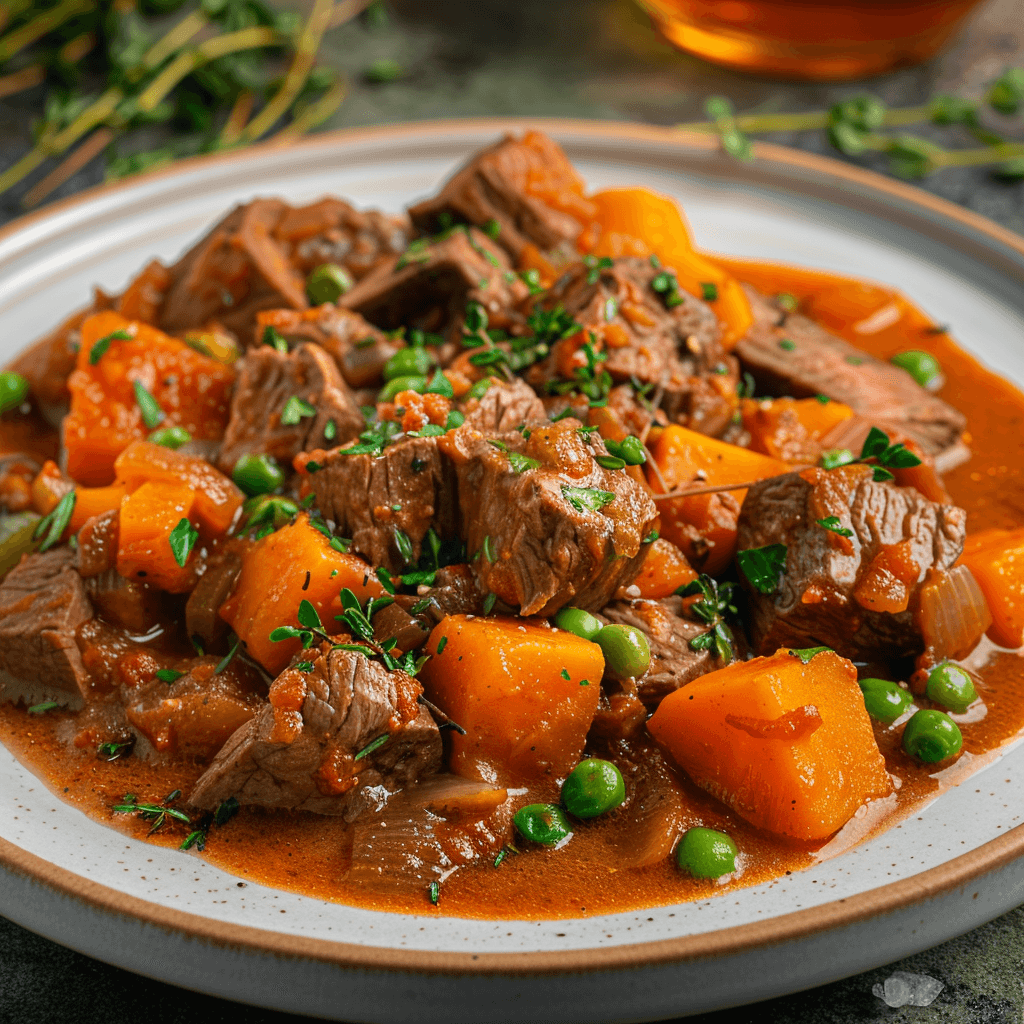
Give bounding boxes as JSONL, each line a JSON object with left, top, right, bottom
{"left": 0, "top": 0, "right": 386, "bottom": 206}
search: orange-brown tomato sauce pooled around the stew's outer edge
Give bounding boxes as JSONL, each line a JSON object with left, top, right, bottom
{"left": 0, "top": 257, "right": 1024, "bottom": 920}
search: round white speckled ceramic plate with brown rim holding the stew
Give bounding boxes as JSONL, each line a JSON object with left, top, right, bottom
{"left": 0, "top": 120, "right": 1024, "bottom": 1022}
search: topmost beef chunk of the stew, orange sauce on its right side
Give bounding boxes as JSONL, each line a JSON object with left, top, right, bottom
{"left": 409, "top": 131, "right": 596, "bottom": 260}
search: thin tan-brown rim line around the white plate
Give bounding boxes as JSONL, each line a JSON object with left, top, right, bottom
{"left": 0, "top": 117, "right": 1024, "bottom": 977}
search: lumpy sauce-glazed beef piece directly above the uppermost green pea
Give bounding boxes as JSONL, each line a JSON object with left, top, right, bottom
{"left": 273, "top": 196, "right": 412, "bottom": 281}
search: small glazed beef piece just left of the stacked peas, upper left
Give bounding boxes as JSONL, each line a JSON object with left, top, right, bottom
{"left": 255, "top": 302, "right": 404, "bottom": 388}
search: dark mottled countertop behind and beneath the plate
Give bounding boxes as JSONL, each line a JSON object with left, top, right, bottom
{"left": 6, "top": 0, "right": 1024, "bottom": 1024}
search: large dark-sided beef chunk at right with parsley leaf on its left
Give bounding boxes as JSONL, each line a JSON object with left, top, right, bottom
{"left": 738, "top": 465, "right": 967, "bottom": 660}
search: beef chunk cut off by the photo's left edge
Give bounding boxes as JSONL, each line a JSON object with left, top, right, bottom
{"left": 0, "top": 547, "right": 92, "bottom": 696}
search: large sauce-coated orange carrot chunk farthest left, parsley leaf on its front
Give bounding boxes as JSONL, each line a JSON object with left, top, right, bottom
{"left": 62, "top": 311, "right": 234, "bottom": 486}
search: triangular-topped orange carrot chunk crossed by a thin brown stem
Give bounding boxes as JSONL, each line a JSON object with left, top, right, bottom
{"left": 647, "top": 424, "right": 790, "bottom": 575}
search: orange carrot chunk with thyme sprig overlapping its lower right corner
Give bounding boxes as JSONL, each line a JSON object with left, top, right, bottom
{"left": 220, "top": 514, "right": 384, "bottom": 675}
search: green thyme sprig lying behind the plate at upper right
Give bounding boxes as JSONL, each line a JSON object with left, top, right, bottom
{"left": 677, "top": 74, "right": 1024, "bottom": 180}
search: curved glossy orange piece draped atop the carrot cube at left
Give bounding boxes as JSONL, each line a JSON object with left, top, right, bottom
{"left": 114, "top": 441, "right": 246, "bottom": 536}
